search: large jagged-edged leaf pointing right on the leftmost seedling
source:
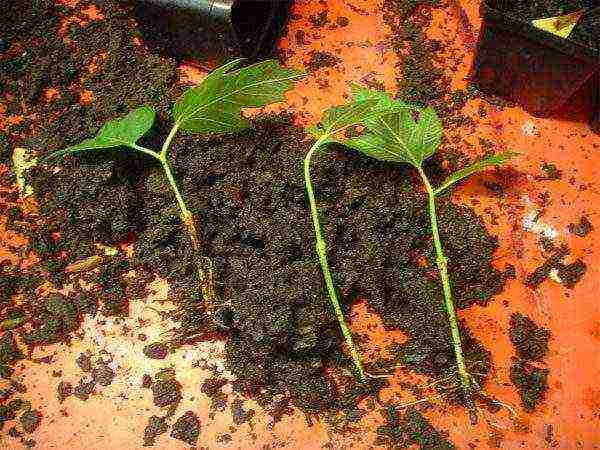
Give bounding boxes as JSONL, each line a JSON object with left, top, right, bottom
{"left": 173, "top": 59, "right": 304, "bottom": 133}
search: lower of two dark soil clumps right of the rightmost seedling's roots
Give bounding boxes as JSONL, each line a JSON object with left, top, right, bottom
{"left": 510, "top": 358, "right": 549, "bottom": 412}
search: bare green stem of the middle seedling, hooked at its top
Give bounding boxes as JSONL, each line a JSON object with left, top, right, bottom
{"left": 304, "top": 138, "right": 366, "bottom": 381}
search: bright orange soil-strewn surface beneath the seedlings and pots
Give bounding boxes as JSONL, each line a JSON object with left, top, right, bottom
{"left": 0, "top": 0, "right": 600, "bottom": 449}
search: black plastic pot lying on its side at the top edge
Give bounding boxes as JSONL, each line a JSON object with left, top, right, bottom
{"left": 130, "top": 0, "right": 293, "bottom": 61}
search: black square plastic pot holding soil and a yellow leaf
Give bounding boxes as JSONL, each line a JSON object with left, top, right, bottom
{"left": 474, "top": 0, "right": 600, "bottom": 129}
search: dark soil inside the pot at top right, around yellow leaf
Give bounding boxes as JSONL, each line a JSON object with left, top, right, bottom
{"left": 492, "top": 0, "right": 600, "bottom": 48}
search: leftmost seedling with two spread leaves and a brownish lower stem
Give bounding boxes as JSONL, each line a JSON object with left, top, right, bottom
{"left": 46, "top": 59, "right": 303, "bottom": 311}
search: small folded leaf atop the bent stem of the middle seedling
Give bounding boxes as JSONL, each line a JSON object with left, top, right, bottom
{"left": 308, "top": 99, "right": 377, "bottom": 139}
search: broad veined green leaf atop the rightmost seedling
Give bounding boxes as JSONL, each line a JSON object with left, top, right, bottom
{"left": 345, "top": 102, "right": 443, "bottom": 168}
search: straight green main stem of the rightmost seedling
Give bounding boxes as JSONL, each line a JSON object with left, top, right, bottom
{"left": 418, "top": 168, "right": 471, "bottom": 394}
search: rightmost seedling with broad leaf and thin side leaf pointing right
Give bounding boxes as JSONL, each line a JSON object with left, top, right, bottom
{"left": 344, "top": 84, "right": 517, "bottom": 412}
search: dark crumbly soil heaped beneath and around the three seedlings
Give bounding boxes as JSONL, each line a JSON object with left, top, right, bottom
{"left": 0, "top": 0, "right": 504, "bottom": 432}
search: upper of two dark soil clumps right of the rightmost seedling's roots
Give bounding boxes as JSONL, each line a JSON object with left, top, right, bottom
{"left": 509, "top": 313, "right": 551, "bottom": 361}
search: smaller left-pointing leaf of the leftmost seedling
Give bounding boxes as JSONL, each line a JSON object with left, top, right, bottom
{"left": 45, "top": 106, "right": 156, "bottom": 160}
